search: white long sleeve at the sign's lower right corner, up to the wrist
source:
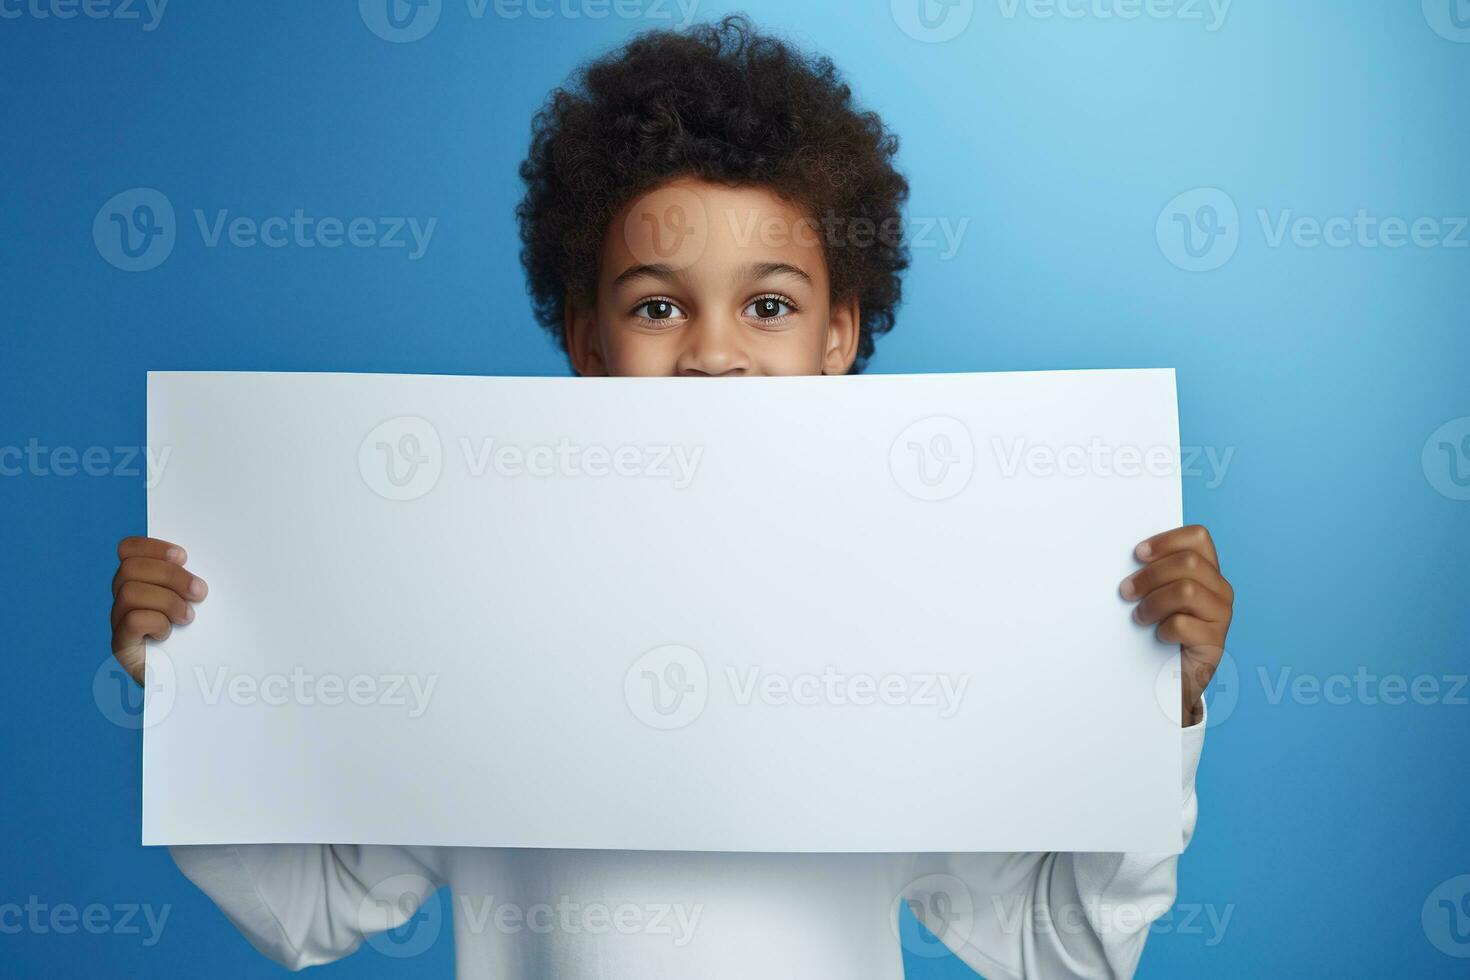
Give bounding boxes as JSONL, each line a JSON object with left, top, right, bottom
{"left": 904, "top": 720, "right": 1205, "bottom": 980}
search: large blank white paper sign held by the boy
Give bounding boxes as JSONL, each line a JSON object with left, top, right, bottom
{"left": 143, "top": 370, "right": 1182, "bottom": 854}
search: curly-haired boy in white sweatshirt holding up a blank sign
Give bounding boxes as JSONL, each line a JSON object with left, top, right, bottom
{"left": 112, "top": 19, "right": 1233, "bottom": 980}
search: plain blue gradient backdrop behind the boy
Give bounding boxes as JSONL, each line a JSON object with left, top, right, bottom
{"left": 0, "top": 0, "right": 1470, "bottom": 977}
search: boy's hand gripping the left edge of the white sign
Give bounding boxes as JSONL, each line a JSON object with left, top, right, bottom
{"left": 112, "top": 538, "right": 209, "bottom": 685}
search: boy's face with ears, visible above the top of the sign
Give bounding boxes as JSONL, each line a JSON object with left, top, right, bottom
{"left": 566, "top": 179, "right": 858, "bottom": 376}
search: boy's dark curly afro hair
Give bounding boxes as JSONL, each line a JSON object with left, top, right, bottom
{"left": 516, "top": 15, "right": 908, "bottom": 373}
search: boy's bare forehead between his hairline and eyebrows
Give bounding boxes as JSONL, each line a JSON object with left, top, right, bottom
{"left": 600, "top": 178, "right": 826, "bottom": 284}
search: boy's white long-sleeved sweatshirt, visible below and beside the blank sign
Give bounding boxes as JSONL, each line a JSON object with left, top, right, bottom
{"left": 171, "top": 721, "right": 1205, "bottom": 980}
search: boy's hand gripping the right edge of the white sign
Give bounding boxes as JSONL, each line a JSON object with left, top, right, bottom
{"left": 1119, "top": 525, "right": 1235, "bottom": 727}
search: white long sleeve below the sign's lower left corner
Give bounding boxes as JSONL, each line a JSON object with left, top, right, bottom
{"left": 169, "top": 843, "right": 442, "bottom": 970}
